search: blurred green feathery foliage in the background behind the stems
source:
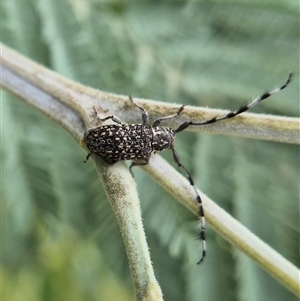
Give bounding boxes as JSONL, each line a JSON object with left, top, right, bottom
{"left": 1, "top": 0, "right": 300, "bottom": 301}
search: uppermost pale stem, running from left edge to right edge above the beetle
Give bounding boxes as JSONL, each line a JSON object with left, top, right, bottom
{"left": 0, "top": 44, "right": 300, "bottom": 144}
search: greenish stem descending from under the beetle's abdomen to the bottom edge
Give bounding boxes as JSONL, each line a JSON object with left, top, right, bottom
{"left": 93, "top": 156, "right": 163, "bottom": 301}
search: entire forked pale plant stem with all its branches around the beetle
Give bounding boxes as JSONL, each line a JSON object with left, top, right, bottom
{"left": 1, "top": 41, "right": 300, "bottom": 300}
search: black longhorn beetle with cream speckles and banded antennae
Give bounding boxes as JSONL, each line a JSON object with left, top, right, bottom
{"left": 83, "top": 73, "right": 292, "bottom": 264}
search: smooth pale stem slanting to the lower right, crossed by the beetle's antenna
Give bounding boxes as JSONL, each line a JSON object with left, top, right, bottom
{"left": 142, "top": 156, "right": 299, "bottom": 295}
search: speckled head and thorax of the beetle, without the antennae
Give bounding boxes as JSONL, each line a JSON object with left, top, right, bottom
{"left": 152, "top": 126, "right": 175, "bottom": 153}
